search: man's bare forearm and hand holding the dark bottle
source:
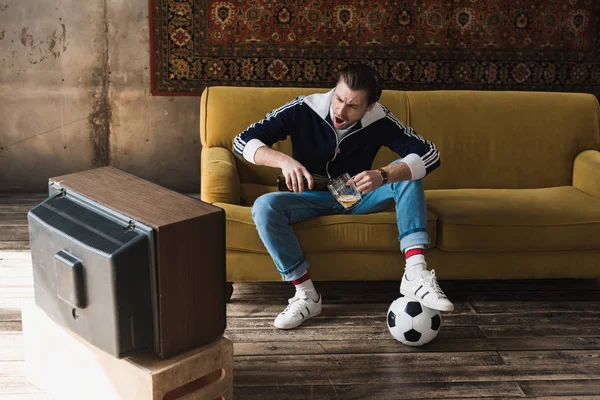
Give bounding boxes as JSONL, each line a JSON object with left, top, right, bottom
{"left": 254, "top": 146, "right": 314, "bottom": 193}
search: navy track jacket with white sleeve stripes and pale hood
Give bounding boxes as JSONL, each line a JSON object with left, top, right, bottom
{"left": 233, "top": 90, "right": 440, "bottom": 179}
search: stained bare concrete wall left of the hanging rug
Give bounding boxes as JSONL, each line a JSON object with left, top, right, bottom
{"left": 0, "top": 0, "right": 200, "bottom": 192}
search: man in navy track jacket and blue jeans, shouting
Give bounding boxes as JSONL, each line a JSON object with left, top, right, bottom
{"left": 234, "top": 64, "right": 454, "bottom": 329}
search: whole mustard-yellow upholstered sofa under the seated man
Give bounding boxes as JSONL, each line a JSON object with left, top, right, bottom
{"left": 200, "top": 87, "right": 600, "bottom": 282}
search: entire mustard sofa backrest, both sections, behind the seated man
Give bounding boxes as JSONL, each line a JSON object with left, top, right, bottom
{"left": 200, "top": 87, "right": 600, "bottom": 189}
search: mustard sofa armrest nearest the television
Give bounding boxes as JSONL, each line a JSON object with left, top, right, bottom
{"left": 200, "top": 147, "right": 240, "bottom": 204}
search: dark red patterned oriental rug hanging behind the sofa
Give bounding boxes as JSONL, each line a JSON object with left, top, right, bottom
{"left": 149, "top": 0, "right": 600, "bottom": 96}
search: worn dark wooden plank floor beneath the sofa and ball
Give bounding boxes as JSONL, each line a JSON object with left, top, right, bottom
{"left": 0, "top": 195, "right": 600, "bottom": 400}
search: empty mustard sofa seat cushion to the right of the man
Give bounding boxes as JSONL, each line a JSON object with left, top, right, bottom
{"left": 426, "top": 186, "right": 600, "bottom": 251}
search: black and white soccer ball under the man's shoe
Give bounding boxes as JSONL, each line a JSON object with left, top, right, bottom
{"left": 387, "top": 297, "right": 442, "bottom": 346}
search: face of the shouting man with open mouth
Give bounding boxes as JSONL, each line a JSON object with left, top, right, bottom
{"left": 331, "top": 80, "right": 375, "bottom": 129}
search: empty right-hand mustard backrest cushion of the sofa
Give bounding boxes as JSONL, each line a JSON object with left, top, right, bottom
{"left": 408, "top": 91, "right": 600, "bottom": 189}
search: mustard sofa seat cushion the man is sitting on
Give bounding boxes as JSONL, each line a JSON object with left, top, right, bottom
{"left": 214, "top": 203, "right": 436, "bottom": 253}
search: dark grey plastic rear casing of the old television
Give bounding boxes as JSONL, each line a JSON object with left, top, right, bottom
{"left": 28, "top": 185, "right": 158, "bottom": 357}
